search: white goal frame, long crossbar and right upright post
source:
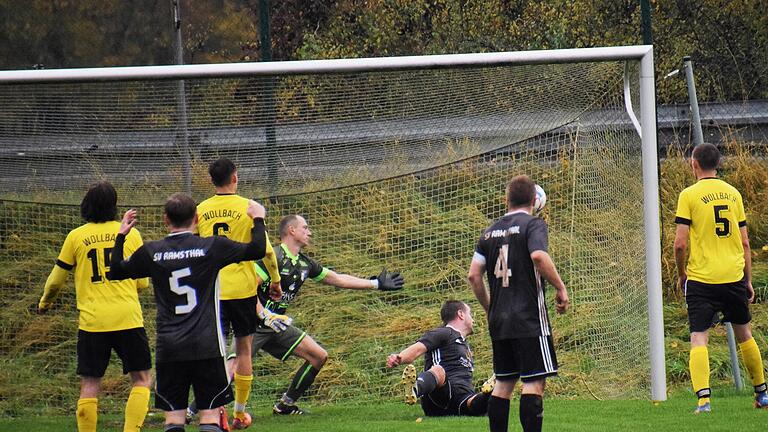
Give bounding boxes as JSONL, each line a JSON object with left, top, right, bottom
{"left": 0, "top": 46, "right": 667, "bottom": 401}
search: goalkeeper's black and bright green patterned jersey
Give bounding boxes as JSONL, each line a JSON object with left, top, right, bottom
{"left": 256, "top": 244, "right": 328, "bottom": 314}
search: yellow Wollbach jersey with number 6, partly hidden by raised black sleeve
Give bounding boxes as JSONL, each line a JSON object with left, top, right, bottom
{"left": 197, "top": 194, "right": 257, "bottom": 300}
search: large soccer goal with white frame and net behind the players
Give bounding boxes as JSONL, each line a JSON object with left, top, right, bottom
{"left": 0, "top": 46, "right": 666, "bottom": 409}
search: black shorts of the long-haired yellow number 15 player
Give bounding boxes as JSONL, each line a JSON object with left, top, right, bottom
{"left": 77, "top": 327, "right": 152, "bottom": 378}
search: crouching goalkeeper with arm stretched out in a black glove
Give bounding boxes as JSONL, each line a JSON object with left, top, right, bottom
{"left": 253, "top": 215, "right": 403, "bottom": 414}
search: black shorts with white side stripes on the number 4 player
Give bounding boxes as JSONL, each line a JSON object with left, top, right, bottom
{"left": 491, "top": 335, "right": 557, "bottom": 382}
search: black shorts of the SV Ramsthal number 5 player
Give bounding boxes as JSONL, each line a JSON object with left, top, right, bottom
{"left": 155, "top": 357, "right": 235, "bottom": 411}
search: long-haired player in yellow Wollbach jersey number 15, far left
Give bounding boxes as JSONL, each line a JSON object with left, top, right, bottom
{"left": 38, "top": 182, "right": 152, "bottom": 432}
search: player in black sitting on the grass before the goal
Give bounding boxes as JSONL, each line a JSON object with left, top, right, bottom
{"left": 387, "top": 300, "right": 491, "bottom": 416}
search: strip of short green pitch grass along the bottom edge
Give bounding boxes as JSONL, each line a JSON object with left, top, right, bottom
{"left": 0, "top": 389, "right": 768, "bottom": 432}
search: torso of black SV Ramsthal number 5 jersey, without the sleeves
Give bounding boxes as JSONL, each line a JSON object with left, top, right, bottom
{"left": 145, "top": 231, "right": 230, "bottom": 362}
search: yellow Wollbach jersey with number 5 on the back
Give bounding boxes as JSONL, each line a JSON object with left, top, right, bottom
{"left": 675, "top": 178, "right": 746, "bottom": 284}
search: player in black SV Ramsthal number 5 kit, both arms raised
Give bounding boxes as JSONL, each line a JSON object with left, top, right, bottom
{"left": 108, "top": 193, "right": 290, "bottom": 432}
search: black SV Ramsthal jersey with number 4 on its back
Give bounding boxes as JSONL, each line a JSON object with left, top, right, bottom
{"left": 477, "top": 212, "right": 550, "bottom": 339}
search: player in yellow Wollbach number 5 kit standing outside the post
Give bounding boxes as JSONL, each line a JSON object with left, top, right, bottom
{"left": 675, "top": 144, "right": 768, "bottom": 414}
